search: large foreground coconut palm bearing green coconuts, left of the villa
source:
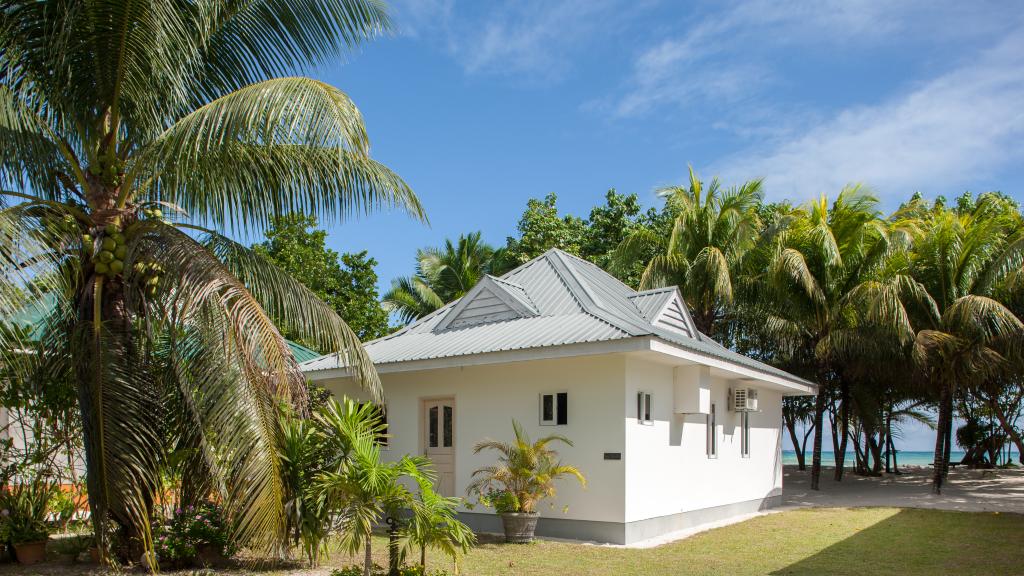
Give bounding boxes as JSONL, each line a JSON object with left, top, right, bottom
{"left": 0, "top": 0, "right": 423, "bottom": 568}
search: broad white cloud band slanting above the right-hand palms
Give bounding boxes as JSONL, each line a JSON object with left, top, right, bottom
{"left": 710, "top": 32, "right": 1024, "bottom": 199}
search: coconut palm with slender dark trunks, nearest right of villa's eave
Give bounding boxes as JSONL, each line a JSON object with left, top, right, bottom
{"left": 743, "top": 186, "right": 890, "bottom": 490}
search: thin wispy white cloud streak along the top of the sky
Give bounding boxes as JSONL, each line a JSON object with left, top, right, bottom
{"left": 601, "top": 0, "right": 1004, "bottom": 117}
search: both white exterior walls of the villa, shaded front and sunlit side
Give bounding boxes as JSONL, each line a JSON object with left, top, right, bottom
{"left": 321, "top": 355, "right": 782, "bottom": 543}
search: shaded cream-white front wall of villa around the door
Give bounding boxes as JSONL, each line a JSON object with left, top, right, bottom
{"left": 321, "top": 355, "right": 626, "bottom": 524}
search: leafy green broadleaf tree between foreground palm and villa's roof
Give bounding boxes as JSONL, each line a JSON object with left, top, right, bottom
{"left": 253, "top": 214, "right": 388, "bottom": 342}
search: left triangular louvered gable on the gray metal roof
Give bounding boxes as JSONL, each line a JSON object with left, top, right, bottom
{"left": 433, "top": 276, "right": 539, "bottom": 332}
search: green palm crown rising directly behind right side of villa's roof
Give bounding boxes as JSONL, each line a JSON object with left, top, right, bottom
{"left": 611, "top": 167, "right": 762, "bottom": 335}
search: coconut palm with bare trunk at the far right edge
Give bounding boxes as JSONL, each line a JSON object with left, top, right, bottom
{"left": 906, "top": 195, "right": 1024, "bottom": 492}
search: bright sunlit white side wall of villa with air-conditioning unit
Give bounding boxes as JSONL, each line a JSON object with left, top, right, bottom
{"left": 624, "top": 358, "right": 782, "bottom": 540}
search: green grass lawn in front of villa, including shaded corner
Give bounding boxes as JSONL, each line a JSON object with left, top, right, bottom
{"left": 0, "top": 508, "right": 1024, "bottom": 576}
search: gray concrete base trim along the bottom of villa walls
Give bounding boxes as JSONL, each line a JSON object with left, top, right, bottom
{"left": 459, "top": 494, "right": 782, "bottom": 544}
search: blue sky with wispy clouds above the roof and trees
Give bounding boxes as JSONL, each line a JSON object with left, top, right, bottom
{"left": 290, "top": 0, "right": 1024, "bottom": 449}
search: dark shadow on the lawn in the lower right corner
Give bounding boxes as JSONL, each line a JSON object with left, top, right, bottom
{"left": 771, "top": 509, "right": 1024, "bottom": 576}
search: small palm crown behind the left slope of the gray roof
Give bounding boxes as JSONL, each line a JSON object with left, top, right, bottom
{"left": 383, "top": 232, "right": 496, "bottom": 324}
